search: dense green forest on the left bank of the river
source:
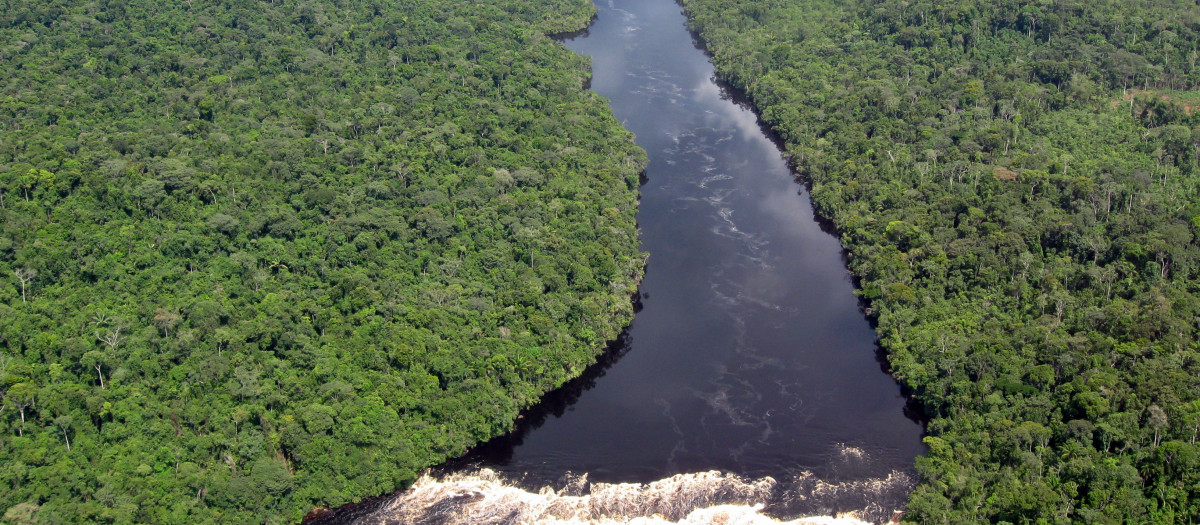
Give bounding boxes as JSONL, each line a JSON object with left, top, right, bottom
{"left": 0, "top": 0, "right": 644, "bottom": 524}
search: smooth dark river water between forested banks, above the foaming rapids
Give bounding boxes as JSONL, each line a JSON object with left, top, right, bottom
{"left": 312, "top": 0, "right": 924, "bottom": 519}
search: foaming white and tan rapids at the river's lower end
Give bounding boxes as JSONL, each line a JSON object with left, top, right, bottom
{"left": 308, "top": 469, "right": 912, "bottom": 525}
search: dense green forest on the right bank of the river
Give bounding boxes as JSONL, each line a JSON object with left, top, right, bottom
{"left": 683, "top": 0, "right": 1200, "bottom": 524}
